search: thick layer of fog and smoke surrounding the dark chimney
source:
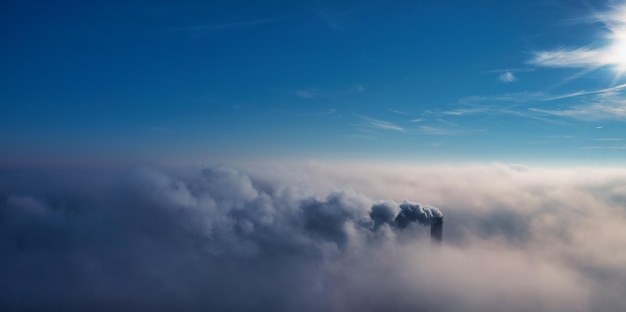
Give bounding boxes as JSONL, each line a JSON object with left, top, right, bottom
{"left": 0, "top": 162, "right": 626, "bottom": 311}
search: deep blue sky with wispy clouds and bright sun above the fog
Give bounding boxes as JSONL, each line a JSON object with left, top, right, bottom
{"left": 0, "top": 0, "right": 626, "bottom": 167}
